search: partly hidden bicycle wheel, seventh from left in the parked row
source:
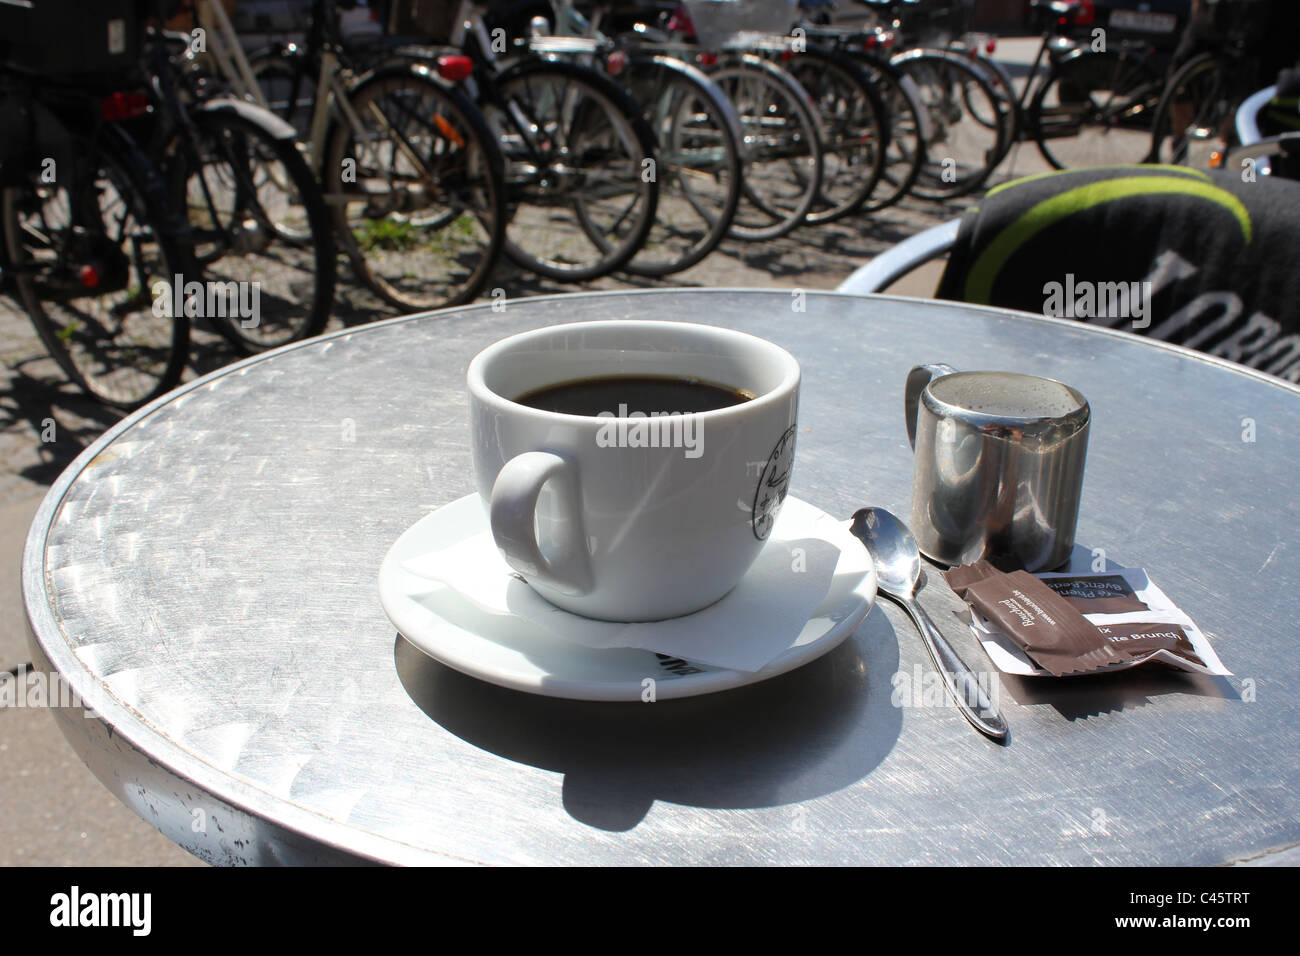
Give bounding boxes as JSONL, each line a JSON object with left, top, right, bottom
{"left": 785, "top": 47, "right": 885, "bottom": 225}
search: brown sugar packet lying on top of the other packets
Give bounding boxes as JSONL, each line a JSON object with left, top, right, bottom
{"left": 944, "top": 562, "right": 1131, "bottom": 678}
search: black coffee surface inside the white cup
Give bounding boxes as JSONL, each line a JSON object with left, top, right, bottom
{"left": 515, "top": 376, "right": 754, "bottom": 418}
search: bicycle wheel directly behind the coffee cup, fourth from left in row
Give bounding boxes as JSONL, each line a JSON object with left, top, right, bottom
{"left": 486, "top": 59, "right": 659, "bottom": 282}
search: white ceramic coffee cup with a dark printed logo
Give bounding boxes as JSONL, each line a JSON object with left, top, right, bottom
{"left": 468, "top": 320, "right": 800, "bottom": 620}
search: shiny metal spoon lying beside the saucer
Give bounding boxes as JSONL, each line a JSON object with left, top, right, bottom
{"left": 849, "top": 507, "right": 1006, "bottom": 740}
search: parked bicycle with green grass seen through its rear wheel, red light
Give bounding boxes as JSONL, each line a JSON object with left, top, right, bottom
{"left": 250, "top": 0, "right": 507, "bottom": 311}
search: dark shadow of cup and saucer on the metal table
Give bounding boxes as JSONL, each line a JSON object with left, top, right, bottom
{"left": 394, "top": 609, "right": 902, "bottom": 831}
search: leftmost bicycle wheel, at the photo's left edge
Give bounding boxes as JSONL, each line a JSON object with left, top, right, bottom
{"left": 0, "top": 128, "right": 190, "bottom": 410}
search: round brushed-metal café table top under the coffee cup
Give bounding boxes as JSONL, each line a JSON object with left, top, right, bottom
{"left": 23, "top": 290, "right": 1300, "bottom": 865}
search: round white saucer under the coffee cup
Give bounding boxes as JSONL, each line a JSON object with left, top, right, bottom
{"left": 380, "top": 494, "right": 876, "bottom": 701}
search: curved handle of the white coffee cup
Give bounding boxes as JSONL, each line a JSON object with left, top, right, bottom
{"left": 489, "top": 451, "right": 593, "bottom": 596}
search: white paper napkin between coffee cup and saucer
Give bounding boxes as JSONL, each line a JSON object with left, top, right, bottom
{"left": 402, "top": 498, "right": 867, "bottom": 672}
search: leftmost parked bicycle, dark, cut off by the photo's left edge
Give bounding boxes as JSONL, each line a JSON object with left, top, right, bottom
{"left": 0, "top": 4, "right": 192, "bottom": 410}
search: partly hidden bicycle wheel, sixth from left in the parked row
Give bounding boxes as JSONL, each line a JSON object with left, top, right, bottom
{"left": 709, "top": 53, "right": 822, "bottom": 242}
